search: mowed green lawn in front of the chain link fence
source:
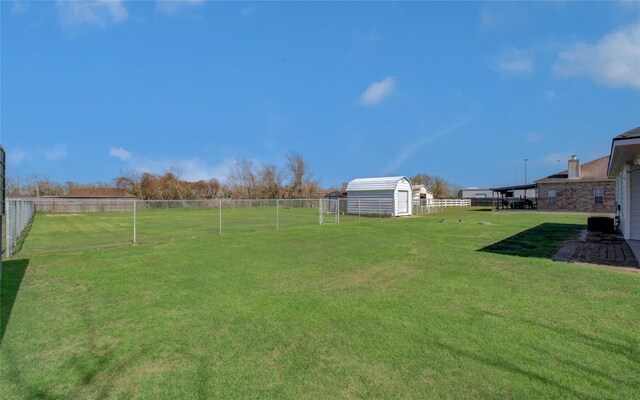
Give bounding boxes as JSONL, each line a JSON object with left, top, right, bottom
{"left": 0, "top": 210, "right": 640, "bottom": 399}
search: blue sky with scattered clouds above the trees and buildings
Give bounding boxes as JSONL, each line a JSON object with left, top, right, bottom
{"left": 0, "top": 1, "right": 640, "bottom": 187}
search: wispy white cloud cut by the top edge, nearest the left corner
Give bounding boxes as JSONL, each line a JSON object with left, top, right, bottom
{"left": 56, "top": 0, "right": 129, "bottom": 27}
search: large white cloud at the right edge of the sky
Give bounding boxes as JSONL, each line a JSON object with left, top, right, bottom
{"left": 554, "top": 23, "right": 640, "bottom": 90}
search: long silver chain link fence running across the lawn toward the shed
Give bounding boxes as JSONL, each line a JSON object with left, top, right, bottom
{"left": 7, "top": 199, "right": 441, "bottom": 255}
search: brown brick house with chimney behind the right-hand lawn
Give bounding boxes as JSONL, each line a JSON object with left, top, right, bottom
{"left": 535, "top": 156, "right": 616, "bottom": 213}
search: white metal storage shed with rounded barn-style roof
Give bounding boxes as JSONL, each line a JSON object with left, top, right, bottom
{"left": 347, "top": 176, "right": 412, "bottom": 217}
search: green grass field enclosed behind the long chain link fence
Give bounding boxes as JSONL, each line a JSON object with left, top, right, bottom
{"left": 20, "top": 207, "right": 328, "bottom": 255}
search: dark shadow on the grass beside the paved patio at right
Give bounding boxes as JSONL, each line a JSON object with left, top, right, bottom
{"left": 478, "top": 223, "right": 585, "bottom": 258}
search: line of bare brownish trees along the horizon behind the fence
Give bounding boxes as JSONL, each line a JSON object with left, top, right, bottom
{"left": 7, "top": 151, "right": 460, "bottom": 200}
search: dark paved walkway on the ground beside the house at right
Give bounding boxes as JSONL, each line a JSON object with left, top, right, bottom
{"left": 551, "top": 230, "right": 640, "bottom": 271}
